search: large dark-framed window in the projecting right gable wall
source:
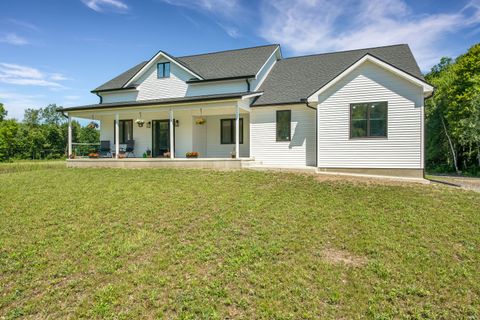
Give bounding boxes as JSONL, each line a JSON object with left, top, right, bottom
{"left": 350, "top": 101, "right": 388, "bottom": 138}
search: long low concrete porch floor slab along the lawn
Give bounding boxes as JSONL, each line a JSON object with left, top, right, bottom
{"left": 66, "top": 158, "right": 254, "bottom": 169}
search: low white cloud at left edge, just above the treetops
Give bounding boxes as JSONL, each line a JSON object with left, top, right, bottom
{"left": 0, "top": 63, "right": 67, "bottom": 89}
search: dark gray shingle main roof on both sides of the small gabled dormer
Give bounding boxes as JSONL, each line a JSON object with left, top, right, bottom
{"left": 92, "top": 44, "right": 278, "bottom": 92}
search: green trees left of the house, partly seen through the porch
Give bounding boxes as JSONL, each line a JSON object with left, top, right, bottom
{"left": 0, "top": 103, "right": 99, "bottom": 161}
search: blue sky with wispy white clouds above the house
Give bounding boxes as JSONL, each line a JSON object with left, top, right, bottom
{"left": 0, "top": 0, "right": 480, "bottom": 119}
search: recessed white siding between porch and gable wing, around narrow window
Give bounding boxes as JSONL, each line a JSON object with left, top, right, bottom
{"left": 250, "top": 105, "right": 315, "bottom": 167}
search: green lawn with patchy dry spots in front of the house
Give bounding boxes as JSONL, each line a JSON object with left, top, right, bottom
{"left": 0, "top": 162, "right": 480, "bottom": 319}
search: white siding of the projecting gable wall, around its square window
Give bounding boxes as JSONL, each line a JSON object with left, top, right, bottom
{"left": 318, "top": 62, "right": 423, "bottom": 168}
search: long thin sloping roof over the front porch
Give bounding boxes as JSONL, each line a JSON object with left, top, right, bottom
{"left": 58, "top": 91, "right": 262, "bottom": 112}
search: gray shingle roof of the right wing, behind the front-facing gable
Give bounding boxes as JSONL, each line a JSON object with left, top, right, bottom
{"left": 253, "top": 44, "right": 423, "bottom": 106}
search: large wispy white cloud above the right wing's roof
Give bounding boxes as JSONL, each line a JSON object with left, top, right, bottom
{"left": 260, "top": 0, "right": 480, "bottom": 69}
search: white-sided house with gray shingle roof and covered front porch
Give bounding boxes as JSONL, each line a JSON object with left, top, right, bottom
{"left": 61, "top": 44, "right": 433, "bottom": 177}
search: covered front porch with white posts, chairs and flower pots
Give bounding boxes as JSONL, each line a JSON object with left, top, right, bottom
{"left": 65, "top": 92, "right": 252, "bottom": 168}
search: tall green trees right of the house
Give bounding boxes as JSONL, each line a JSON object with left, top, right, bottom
{"left": 425, "top": 44, "right": 480, "bottom": 175}
